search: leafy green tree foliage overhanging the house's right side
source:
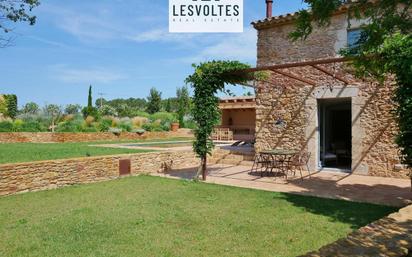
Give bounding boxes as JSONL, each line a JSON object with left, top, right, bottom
{"left": 290, "top": 0, "right": 412, "bottom": 183}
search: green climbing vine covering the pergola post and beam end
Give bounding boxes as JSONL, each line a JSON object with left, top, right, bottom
{"left": 186, "top": 61, "right": 256, "bottom": 180}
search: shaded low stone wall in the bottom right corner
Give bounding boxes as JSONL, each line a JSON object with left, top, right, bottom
{"left": 303, "top": 205, "right": 412, "bottom": 257}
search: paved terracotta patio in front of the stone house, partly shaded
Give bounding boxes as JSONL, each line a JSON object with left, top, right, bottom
{"left": 156, "top": 164, "right": 412, "bottom": 207}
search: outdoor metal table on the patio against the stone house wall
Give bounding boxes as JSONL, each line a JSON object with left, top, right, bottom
{"left": 253, "top": 149, "right": 299, "bottom": 178}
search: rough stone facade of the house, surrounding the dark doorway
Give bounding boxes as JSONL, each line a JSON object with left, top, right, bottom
{"left": 254, "top": 13, "right": 409, "bottom": 177}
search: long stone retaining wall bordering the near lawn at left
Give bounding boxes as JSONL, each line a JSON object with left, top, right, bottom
{"left": 0, "top": 151, "right": 199, "bottom": 196}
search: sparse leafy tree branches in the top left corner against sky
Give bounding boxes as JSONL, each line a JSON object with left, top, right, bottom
{"left": 0, "top": 0, "right": 40, "bottom": 48}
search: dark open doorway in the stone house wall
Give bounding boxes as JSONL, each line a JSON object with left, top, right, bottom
{"left": 318, "top": 98, "right": 352, "bottom": 171}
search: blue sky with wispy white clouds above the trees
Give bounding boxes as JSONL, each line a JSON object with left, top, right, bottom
{"left": 0, "top": 0, "right": 304, "bottom": 106}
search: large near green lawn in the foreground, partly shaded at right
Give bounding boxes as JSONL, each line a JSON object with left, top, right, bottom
{"left": 0, "top": 176, "right": 395, "bottom": 257}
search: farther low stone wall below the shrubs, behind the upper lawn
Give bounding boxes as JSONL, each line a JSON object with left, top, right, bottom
{"left": 0, "top": 130, "right": 193, "bottom": 143}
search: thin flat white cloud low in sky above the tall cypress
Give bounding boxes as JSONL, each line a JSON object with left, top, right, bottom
{"left": 51, "top": 65, "right": 128, "bottom": 84}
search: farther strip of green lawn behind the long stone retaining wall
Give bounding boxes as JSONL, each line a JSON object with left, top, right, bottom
{"left": 0, "top": 138, "right": 192, "bottom": 164}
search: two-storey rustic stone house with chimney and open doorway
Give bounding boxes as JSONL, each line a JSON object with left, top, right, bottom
{"left": 252, "top": 0, "right": 408, "bottom": 177}
